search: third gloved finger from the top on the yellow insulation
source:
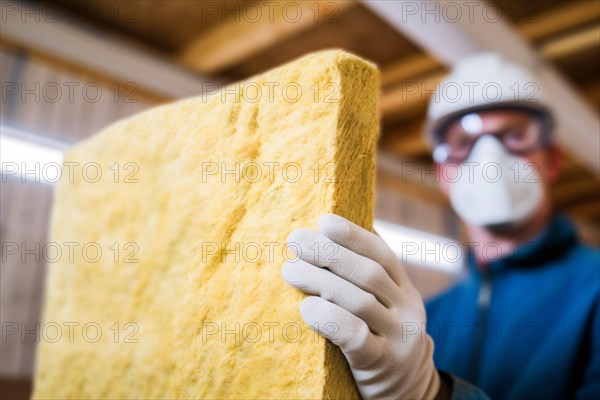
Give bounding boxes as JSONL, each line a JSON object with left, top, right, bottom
{"left": 281, "top": 260, "right": 391, "bottom": 334}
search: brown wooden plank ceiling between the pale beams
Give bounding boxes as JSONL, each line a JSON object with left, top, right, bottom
{"left": 54, "top": 0, "right": 600, "bottom": 225}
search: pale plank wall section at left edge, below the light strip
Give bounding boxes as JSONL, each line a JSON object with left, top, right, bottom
{"left": 0, "top": 177, "right": 52, "bottom": 376}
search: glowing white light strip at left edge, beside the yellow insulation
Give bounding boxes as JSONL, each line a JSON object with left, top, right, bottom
{"left": 0, "top": 125, "right": 67, "bottom": 184}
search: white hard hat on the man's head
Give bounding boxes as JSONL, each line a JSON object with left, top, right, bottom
{"left": 426, "top": 53, "right": 552, "bottom": 144}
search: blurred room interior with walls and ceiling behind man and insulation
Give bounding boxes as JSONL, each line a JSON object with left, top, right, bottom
{"left": 0, "top": 0, "right": 600, "bottom": 398}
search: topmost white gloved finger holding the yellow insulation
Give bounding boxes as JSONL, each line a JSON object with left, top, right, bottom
{"left": 318, "top": 214, "right": 405, "bottom": 286}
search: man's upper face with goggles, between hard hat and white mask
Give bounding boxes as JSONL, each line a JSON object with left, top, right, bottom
{"left": 436, "top": 110, "right": 561, "bottom": 216}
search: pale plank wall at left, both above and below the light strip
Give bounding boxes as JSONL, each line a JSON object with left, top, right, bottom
{"left": 0, "top": 46, "right": 155, "bottom": 378}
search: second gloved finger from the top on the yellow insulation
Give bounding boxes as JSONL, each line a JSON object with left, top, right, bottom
{"left": 288, "top": 229, "right": 398, "bottom": 307}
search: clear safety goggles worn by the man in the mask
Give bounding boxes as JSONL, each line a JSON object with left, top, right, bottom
{"left": 433, "top": 109, "right": 548, "bottom": 163}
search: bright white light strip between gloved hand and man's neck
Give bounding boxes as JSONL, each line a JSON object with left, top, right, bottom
{"left": 374, "top": 219, "right": 464, "bottom": 274}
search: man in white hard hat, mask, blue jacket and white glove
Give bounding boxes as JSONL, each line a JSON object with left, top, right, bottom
{"left": 282, "top": 54, "right": 600, "bottom": 399}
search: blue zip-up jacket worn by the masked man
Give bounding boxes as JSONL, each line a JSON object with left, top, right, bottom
{"left": 426, "top": 216, "right": 600, "bottom": 400}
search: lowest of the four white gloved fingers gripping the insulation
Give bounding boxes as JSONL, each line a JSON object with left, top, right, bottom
{"left": 300, "top": 296, "right": 382, "bottom": 368}
